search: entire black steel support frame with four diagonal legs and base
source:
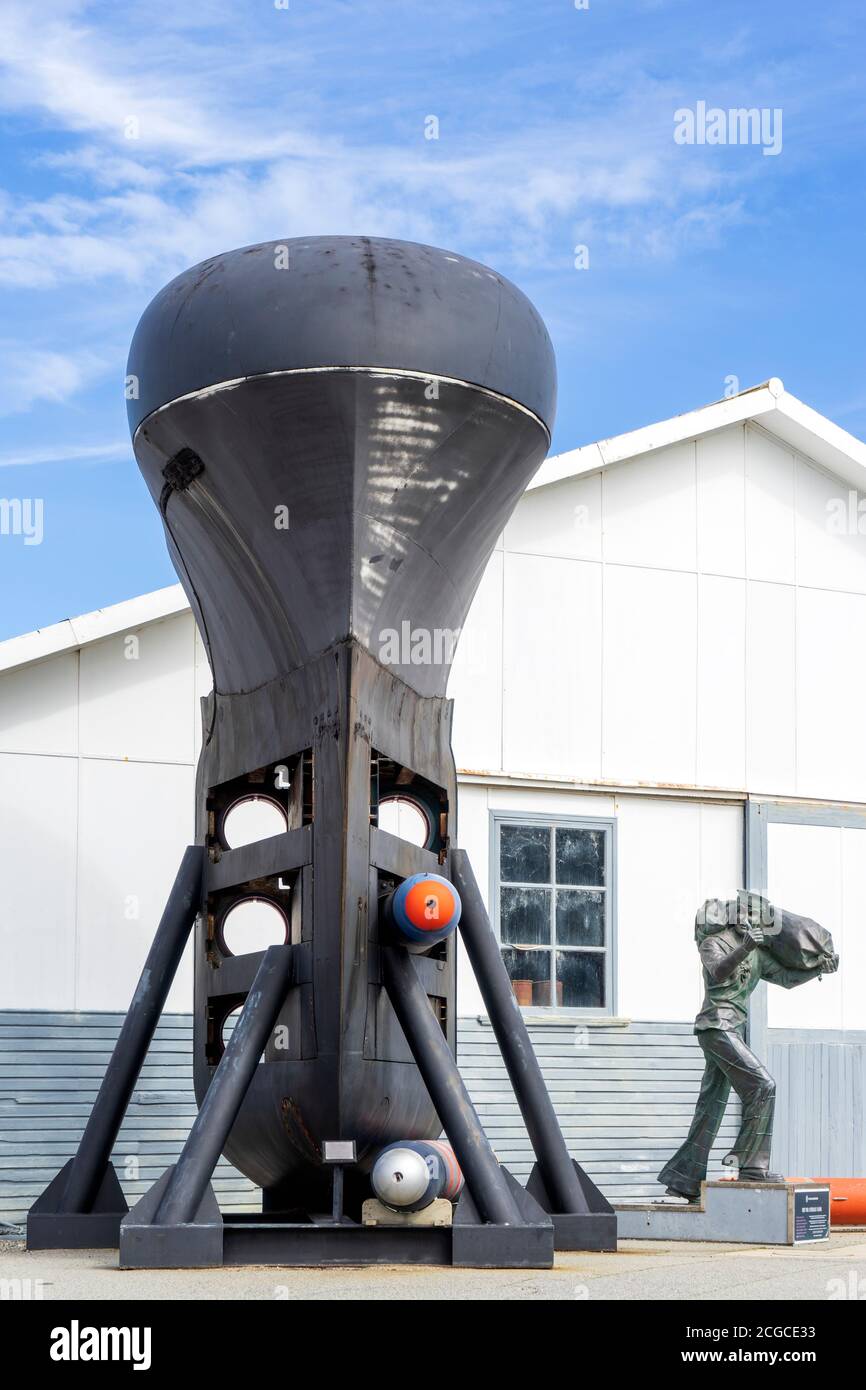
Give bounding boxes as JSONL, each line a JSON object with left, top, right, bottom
{"left": 28, "top": 847, "right": 616, "bottom": 1268}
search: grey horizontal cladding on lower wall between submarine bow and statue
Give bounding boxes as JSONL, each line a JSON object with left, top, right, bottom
{"left": 457, "top": 1019, "right": 740, "bottom": 1201}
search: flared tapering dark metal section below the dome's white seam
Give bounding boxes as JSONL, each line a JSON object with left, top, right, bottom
{"left": 135, "top": 371, "right": 548, "bottom": 700}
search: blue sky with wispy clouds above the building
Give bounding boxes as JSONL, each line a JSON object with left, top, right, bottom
{"left": 0, "top": 0, "right": 866, "bottom": 638}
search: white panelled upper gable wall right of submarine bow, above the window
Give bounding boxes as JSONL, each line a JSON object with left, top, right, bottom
{"left": 450, "top": 424, "right": 866, "bottom": 801}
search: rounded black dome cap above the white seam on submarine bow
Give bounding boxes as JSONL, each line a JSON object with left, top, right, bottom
{"left": 126, "top": 236, "right": 556, "bottom": 436}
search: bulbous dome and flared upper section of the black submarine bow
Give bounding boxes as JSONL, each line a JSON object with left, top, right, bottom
{"left": 128, "top": 236, "right": 556, "bottom": 706}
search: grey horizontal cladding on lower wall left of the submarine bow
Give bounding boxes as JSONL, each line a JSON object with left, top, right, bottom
{"left": 0, "top": 1011, "right": 260, "bottom": 1226}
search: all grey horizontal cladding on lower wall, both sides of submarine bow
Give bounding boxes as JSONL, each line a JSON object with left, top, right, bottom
{"left": 0, "top": 1012, "right": 737, "bottom": 1226}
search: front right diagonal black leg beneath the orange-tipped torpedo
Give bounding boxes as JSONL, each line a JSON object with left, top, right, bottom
{"left": 382, "top": 947, "right": 521, "bottom": 1226}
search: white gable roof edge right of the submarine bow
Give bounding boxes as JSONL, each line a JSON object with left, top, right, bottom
{"left": 527, "top": 377, "right": 866, "bottom": 491}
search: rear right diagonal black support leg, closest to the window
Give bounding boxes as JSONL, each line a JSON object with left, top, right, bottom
{"left": 450, "top": 849, "right": 589, "bottom": 1212}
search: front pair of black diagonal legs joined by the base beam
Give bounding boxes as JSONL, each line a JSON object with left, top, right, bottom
{"left": 120, "top": 945, "right": 553, "bottom": 1268}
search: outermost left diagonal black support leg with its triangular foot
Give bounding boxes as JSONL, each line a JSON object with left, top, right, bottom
{"left": 26, "top": 845, "right": 204, "bottom": 1250}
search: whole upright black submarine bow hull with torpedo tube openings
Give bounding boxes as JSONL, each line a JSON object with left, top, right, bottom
{"left": 129, "top": 238, "right": 555, "bottom": 1211}
